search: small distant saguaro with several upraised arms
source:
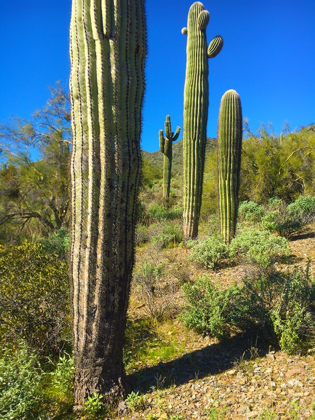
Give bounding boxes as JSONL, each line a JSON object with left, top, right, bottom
{"left": 159, "top": 115, "right": 180, "bottom": 199}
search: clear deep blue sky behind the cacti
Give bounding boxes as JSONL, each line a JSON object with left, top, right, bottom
{"left": 0, "top": 0, "right": 315, "bottom": 151}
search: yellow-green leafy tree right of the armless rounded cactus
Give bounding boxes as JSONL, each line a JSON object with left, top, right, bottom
{"left": 240, "top": 124, "right": 315, "bottom": 203}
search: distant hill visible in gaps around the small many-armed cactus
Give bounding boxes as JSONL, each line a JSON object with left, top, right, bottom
{"left": 142, "top": 137, "right": 217, "bottom": 176}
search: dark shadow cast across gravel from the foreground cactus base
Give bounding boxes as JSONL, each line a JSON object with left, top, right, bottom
{"left": 127, "top": 334, "right": 269, "bottom": 393}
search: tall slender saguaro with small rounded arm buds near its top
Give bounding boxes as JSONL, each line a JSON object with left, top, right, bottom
{"left": 182, "top": 2, "right": 223, "bottom": 239}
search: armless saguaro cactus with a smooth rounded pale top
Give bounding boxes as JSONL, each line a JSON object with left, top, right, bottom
{"left": 218, "top": 90, "right": 242, "bottom": 243}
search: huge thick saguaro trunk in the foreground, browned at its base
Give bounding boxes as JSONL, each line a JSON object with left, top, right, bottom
{"left": 70, "top": 0, "right": 146, "bottom": 407}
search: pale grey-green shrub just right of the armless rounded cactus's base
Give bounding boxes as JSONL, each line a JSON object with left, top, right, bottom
{"left": 230, "top": 228, "right": 291, "bottom": 268}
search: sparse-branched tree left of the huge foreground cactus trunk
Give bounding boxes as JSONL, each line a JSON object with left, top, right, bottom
{"left": 0, "top": 84, "right": 71, "bottom": 241}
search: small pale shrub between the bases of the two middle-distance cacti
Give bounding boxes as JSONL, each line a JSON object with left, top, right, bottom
{"left": 190, "top": 234, "right": 229, "bottom": 268}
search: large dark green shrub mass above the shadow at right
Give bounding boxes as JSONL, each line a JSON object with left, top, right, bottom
{"left": 183, "top": 270, "right": 315, "bottom": 354}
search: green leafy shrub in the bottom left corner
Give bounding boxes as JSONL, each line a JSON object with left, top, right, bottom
{"left": 0, "top": 343, "right": 43, "bottom": 420}
